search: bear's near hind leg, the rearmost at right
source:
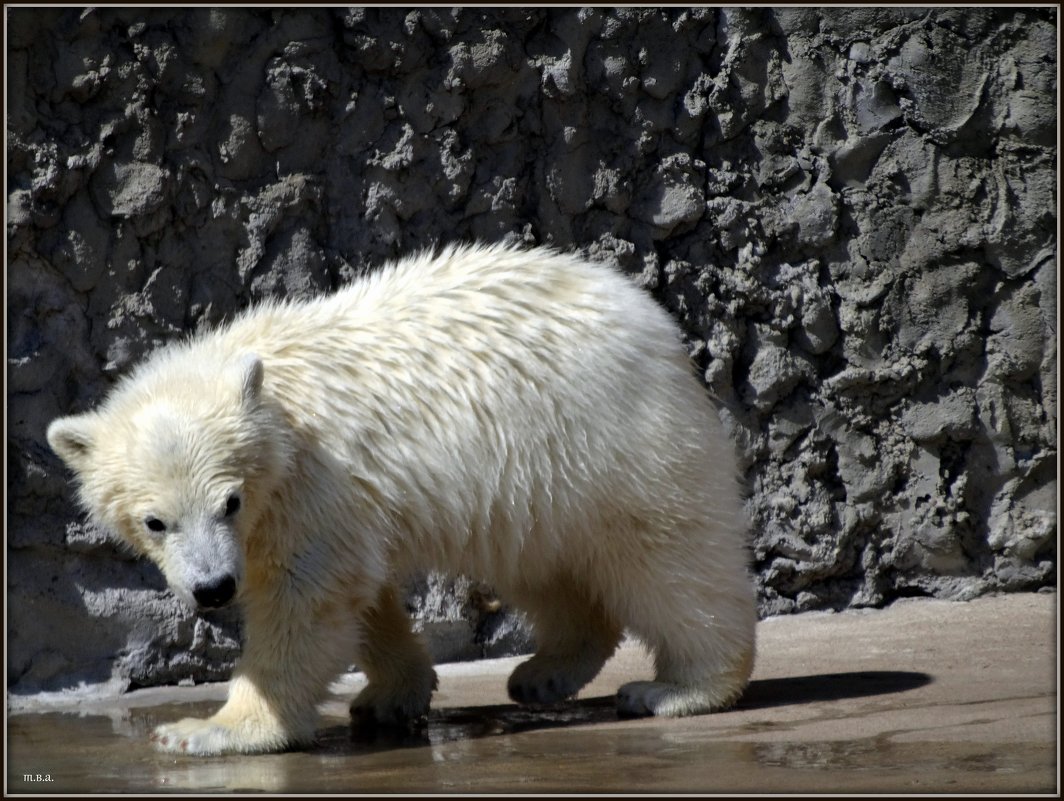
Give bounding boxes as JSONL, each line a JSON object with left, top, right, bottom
{"left": 617, "top": 579, "right": 757, "bottom": 717}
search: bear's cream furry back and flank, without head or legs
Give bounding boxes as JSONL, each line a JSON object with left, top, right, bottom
{"left": 126, "top": 240, "right": 738, "bottom": 573}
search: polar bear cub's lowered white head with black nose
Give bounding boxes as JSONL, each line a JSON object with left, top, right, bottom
{"left": 48, "top": 348, "right": 284, "bottom": 608}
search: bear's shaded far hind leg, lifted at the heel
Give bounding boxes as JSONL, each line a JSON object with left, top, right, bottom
{"left": 506, "top": 585, "right": 621, "bottom": 703}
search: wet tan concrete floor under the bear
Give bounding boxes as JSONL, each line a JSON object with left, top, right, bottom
{"left": 6, "top": 595, "right": 1059, "bottom": 795}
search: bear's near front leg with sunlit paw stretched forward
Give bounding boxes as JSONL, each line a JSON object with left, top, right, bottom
{"left": 151, "top": 591, "right": 355, "bottom": 754}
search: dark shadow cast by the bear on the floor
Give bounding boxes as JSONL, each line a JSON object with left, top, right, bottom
{"left": 314, "top": 670, "right": 932, "bottom": 754}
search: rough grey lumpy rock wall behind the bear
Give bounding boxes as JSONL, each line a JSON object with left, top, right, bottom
{"left": 6, "top": 9, "right": 1057, "bottom": 690}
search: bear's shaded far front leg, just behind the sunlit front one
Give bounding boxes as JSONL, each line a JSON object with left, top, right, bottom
{"left": 351, "top": 586, "right": 436, "bottom": 728}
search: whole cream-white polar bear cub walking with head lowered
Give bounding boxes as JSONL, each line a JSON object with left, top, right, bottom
{"left": 48, "top": 240, "right": 757, "bottom": 754}
